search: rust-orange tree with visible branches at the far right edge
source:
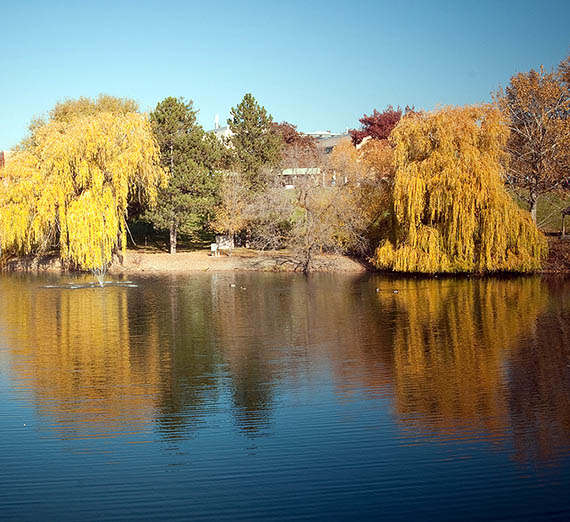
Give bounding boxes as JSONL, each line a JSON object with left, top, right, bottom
{"left": 495, "top": 62, "right": 570, "bottom": 223}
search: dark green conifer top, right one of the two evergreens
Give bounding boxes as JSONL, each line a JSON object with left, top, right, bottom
{"left": 228, "top": 93, "right": 282, "bottom": 191}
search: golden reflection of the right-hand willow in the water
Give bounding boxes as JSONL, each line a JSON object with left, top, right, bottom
{"left": 377, "top": 277, "right": 549, "bottom": 433}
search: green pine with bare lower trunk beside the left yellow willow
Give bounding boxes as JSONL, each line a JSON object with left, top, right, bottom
{"left": 145, "top": 97, "right": 221, "bottom": 254}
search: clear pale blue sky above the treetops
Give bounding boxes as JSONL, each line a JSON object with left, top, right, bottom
{"left": 0, "top": 0, "right": 570, "bottom": 146}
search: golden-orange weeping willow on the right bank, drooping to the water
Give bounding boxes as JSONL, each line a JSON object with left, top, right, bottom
{"left": 375, "top": 106, "right": 547, "bottom": 273}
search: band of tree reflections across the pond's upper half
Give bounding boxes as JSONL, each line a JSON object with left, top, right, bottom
{"left": 0, "top": 274, "right": 570, "bottom": 460}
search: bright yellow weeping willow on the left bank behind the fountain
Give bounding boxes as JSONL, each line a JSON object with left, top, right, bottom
{"left": 0, "top": 112, "right": 166, "bottom": 270}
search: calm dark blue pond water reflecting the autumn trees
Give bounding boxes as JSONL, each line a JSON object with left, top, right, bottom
{"left": 0, "top": 273, "right": 570, "bottom": 521}
